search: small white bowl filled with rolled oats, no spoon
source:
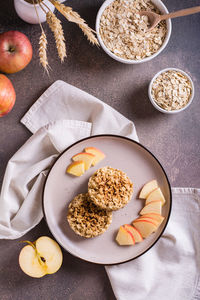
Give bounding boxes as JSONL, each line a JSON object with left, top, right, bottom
{"left": 148, "top": 68, "right": 194, "bottom": 114}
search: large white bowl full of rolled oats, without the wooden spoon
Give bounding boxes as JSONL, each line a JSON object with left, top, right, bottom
{"left": 96, "top": 0, "right": 172, "bottom": 64}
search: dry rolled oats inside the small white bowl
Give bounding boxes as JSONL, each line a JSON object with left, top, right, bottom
{"left": 151, "top": 70, "right": 192, "bottom": 111}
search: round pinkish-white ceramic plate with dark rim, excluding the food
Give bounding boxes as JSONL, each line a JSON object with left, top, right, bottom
{"left": 43, "top": 135, "right": 171, "bottom": 265}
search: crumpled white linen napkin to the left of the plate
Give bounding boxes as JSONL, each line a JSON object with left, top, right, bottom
{"left": 0, "top": 81, "right": 138, "bottom": 239}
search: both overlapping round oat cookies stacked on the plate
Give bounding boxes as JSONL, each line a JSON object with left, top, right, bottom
{"left": 67, "top": 167, "right": 133, "bottom": 238}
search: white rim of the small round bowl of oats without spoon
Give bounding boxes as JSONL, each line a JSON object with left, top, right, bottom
{"left": 148, "top": 67, "right": 194, "bottom": 114}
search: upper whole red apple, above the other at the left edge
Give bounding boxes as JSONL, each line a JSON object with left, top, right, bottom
{"left": 0, "top": 30, "right": 33, "bottom": 74}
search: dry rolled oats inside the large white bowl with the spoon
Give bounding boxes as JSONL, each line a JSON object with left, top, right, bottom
{"left": 99, "top": 0, "right": 167, "bottom": 60}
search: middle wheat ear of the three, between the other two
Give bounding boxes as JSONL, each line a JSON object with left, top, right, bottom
{"left": 46, "top": 11, "right": 67, "bottom": 62}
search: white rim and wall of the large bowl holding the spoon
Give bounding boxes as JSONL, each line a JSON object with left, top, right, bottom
{"left": 95, "top": 0, "right": 172, "bottom": 64}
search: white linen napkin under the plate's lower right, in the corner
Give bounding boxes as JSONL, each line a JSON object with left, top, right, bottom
{"left": 106, "top": 188, "right": 200, "bottom": 300}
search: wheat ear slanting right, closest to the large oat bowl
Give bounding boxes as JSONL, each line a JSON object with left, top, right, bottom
{"left": 49, "top": 0, "right": 99, "bottom": 46}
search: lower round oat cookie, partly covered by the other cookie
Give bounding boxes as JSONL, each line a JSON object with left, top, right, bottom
{"left": 67, "top": 194, "right": 112, "bottom": 238}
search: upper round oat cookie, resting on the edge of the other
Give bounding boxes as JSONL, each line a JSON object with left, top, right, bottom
{"left": 88, "top": 167, "right": 133, "bottom": 210}
